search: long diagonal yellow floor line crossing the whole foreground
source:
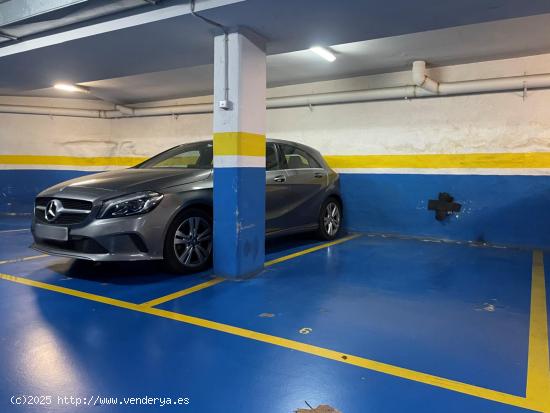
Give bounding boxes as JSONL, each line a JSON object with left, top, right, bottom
{"left": 0, "top": 273, "right": 540, "bottom": 410}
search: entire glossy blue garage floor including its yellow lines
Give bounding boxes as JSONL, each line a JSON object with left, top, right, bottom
{"left": 0, "top": 218, "right": 550, "bottom": 413}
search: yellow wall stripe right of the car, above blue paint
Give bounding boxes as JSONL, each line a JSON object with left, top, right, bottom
{"left": 325, "top": 152, "right": 550, "bottom": 169}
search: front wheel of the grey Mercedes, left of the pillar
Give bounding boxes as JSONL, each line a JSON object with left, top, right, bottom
{"left": 164, "top": 209, "right": 213, "bottom": 273}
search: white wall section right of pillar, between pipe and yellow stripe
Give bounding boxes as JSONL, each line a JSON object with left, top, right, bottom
{"left": 268, "top": 91, "right": 550, "bottom": 155}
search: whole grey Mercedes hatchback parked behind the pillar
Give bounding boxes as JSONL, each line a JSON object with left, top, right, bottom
{"left": 32, "top": 140, "right": 343, "bottom": 273}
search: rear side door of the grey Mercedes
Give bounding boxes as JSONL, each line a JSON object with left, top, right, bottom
{"left": 279, "top": 144, "right": 328, "bottom": 227}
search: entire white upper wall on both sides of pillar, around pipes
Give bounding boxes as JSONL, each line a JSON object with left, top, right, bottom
{"left": 0, "top": 55, "right": 550, "bottom": 161}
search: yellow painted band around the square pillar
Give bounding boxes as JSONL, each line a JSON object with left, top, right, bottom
{"left": 214, "top": 132, "right": 265, "bottom": 156}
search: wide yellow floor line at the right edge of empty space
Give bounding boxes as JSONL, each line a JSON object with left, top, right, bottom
{"left": 526, "top": 250, "right": 550, "bottom": 413}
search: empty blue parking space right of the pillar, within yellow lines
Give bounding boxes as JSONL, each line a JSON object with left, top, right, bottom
{"left": 157, "top": 237, "right": 531, "bottom": 395}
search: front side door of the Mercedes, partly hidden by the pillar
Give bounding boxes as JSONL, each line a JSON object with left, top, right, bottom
{"left": 265, "top": 142, "right": 296, "bottom": 233}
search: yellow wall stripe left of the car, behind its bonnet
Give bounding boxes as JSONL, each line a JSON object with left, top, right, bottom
{"left": 0, "top": 155, "right": 147, "bottom": 166}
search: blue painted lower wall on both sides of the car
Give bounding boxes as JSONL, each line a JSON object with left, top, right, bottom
{"left": 4, "top": 170, "right": 550, "bottom": 248}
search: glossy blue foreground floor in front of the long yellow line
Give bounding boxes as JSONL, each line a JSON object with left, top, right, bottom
{"left": 0, "top": 270, "right": 536, "bottom": 412}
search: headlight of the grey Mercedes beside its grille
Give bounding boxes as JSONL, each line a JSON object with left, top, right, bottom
{"left": 98, "top": 191, "right": 164, "bottom": 218}
